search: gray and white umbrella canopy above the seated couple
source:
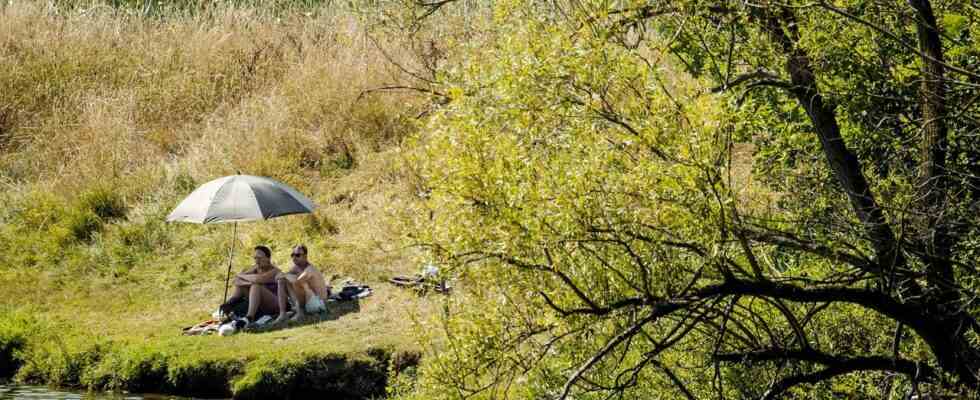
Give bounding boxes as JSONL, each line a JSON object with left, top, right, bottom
{"left": 167, "top": 175, "right": 314, "bottom": 224}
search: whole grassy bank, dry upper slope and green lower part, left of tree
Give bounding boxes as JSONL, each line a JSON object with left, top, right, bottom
{"left": 0, "top": 3, "right": 435, "bottom": 398}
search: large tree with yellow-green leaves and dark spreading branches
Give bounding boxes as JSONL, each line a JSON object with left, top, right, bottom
{"left": 394, "top": 0, "right": 980, "bottom": 399}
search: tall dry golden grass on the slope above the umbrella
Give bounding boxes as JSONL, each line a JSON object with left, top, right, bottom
{"left": 0, "top": 2, "right": 413, "bottom": 194}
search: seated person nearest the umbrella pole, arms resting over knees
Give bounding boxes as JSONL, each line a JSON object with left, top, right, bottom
{"left": 221, "top": 246, "right": 286, "bottom": 323}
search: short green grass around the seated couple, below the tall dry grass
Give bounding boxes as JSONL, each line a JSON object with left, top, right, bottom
{"left": 0, "top": 152, "right": 437, "bottom": 396}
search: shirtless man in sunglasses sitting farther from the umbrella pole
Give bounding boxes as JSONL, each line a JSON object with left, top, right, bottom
{"left": 275, "top": 244, "right": 330, "bottom": 323}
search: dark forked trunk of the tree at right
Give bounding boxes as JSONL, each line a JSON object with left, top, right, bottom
{"left": 760, "top": 5, "right": 980, "bottom": 389}
